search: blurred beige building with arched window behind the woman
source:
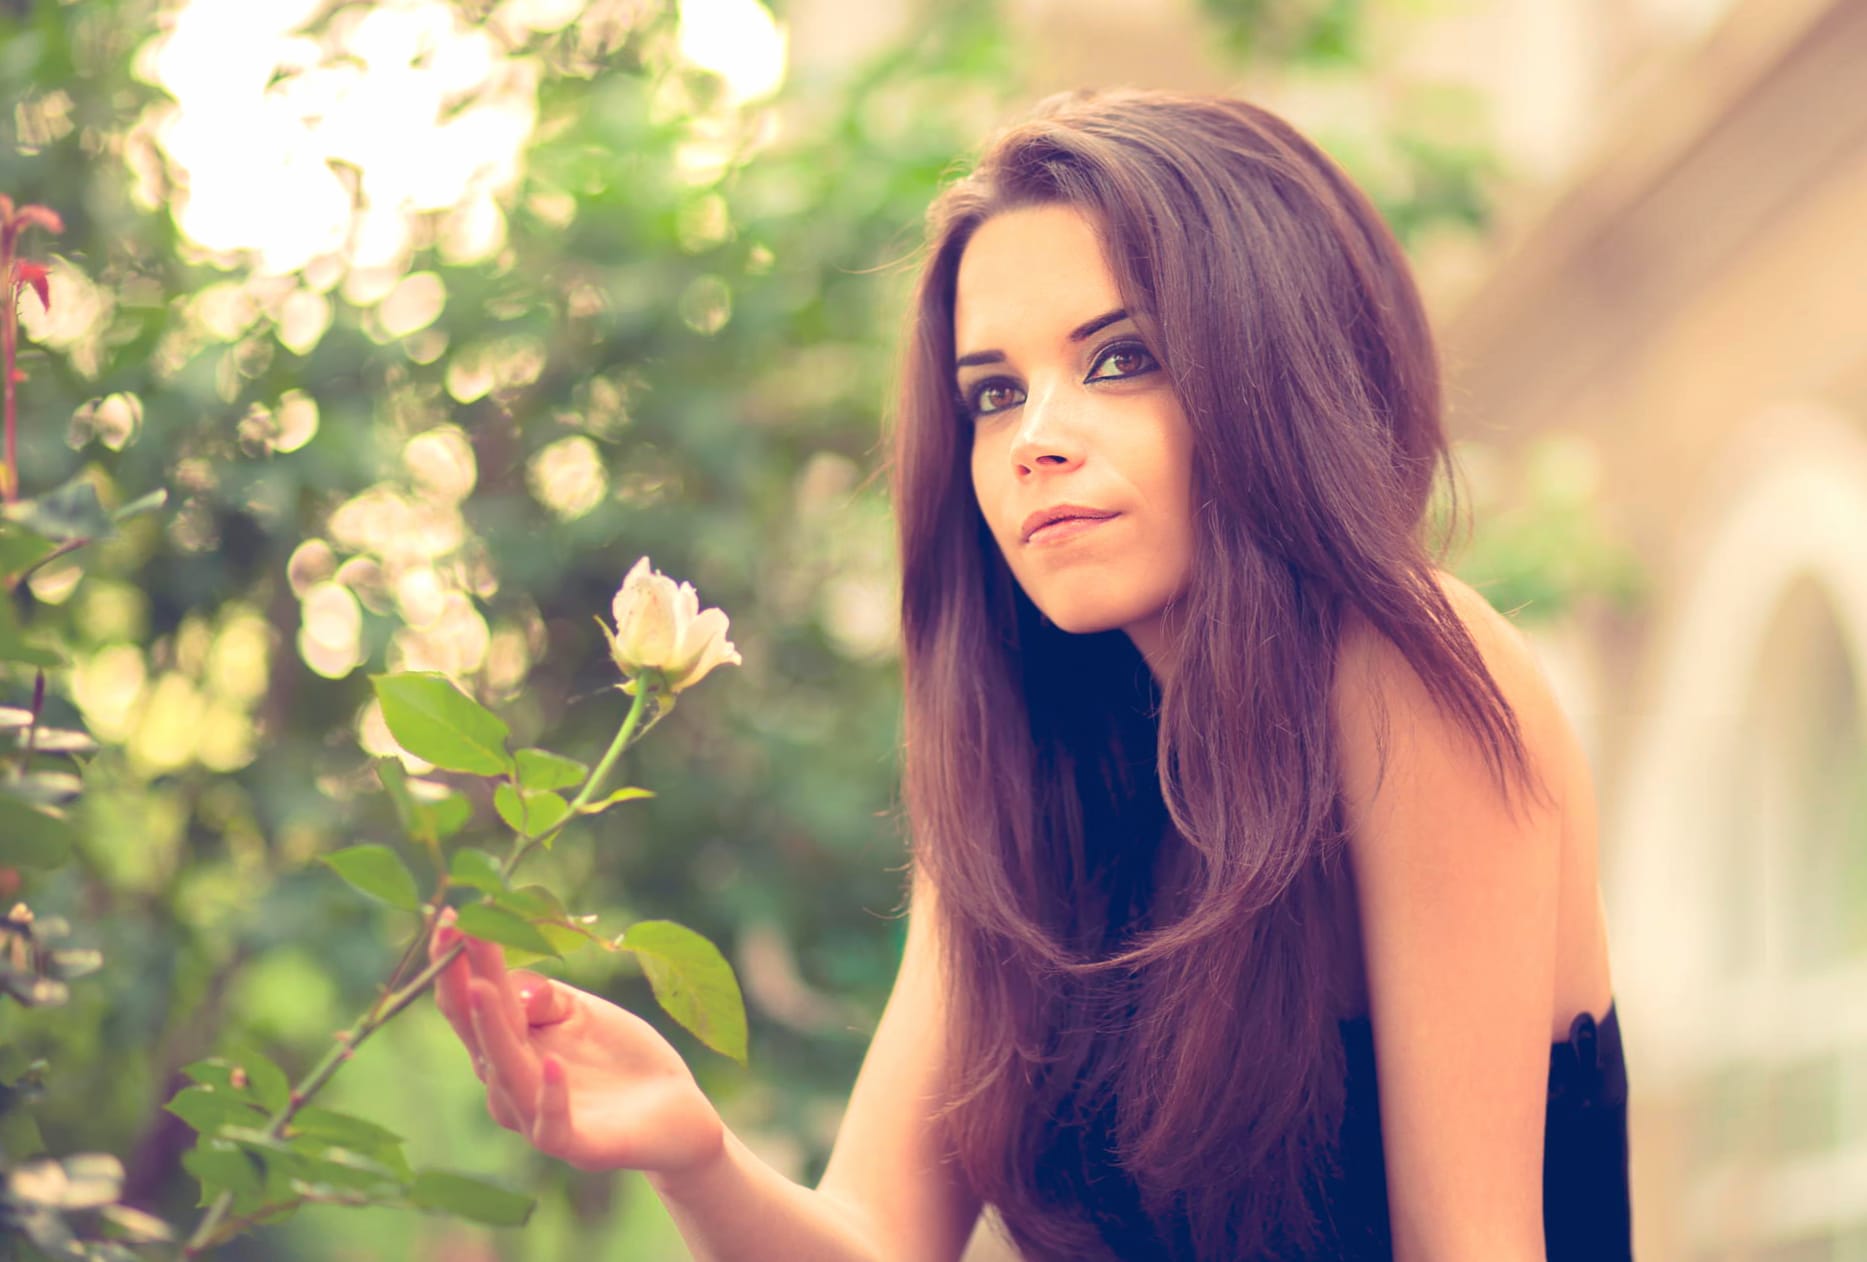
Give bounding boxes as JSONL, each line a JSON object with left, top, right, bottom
{"left": 788, "top": 0, "right": 1867, "bottom": 1262}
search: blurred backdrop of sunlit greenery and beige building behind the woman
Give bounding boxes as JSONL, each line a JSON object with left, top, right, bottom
{"left": 0, "top": 0, "right": 1867, "bottom": 1262}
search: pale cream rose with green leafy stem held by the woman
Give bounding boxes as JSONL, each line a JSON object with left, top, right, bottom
{"left": 168, "top": 556, "right": 747, "bottom": 1256}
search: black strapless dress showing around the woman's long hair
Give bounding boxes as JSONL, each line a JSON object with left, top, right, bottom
{"left": 1040, "top": 1004, "right": 1634, "bottom": 1262}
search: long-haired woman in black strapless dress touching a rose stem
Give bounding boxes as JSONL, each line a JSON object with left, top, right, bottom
{"left": 437, "top": 93, "right": 1628, "bottom": 1262}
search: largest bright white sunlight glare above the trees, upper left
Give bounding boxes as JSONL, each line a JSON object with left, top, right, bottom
{"left": 138, "top": 0, "right": 541, "bottom": 276}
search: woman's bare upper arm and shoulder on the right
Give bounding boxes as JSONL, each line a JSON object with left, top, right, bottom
{"left": 1333, "top": 581, "right": 1585, "bottom": 1262}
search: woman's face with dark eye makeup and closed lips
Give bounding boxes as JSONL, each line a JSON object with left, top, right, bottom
{"left": 952, "top": 205, "right": 1193, "bottom": 674}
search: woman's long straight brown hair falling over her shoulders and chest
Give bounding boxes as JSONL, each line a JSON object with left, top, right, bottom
{"left": 892, "top": 91, "right": 1523, "bottom": 1260}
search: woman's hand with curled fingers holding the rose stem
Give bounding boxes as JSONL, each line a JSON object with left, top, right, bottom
{"left": 428, "top": 911, "right": 724, "bottom": 1174}
